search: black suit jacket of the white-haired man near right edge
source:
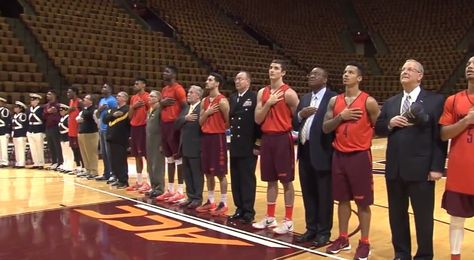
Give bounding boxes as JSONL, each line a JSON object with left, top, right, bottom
{"left": 375, "top": 88, "right": 447, "bottom": 181}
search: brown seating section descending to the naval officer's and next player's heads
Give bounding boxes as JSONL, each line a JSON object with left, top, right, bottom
{"left": 148, "top": 0, "right": 307, "bottom": 92}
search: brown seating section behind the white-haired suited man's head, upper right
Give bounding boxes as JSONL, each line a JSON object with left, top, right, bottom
{"left": 353, "top": 0, "right": 474, "bottom": 98}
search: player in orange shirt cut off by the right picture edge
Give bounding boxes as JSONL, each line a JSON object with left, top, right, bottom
{"left": 439, "top": 56, "right": 474, "bottom": 259}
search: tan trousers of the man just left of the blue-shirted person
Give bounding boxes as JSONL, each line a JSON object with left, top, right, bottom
{"left": 77, "top": 132, "right": 99, "bottom": 175}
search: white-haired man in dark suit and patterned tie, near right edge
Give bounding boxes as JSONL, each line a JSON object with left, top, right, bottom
{"left": 375, "top": 60, "right": 446, "bottom": 259}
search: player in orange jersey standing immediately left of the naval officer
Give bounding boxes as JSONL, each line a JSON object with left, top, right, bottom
{"left": 196, "top": 73, "right": 230, "bottom": 216}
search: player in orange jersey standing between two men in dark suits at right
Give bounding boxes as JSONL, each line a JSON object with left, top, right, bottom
{"left": 323, "top": 62, "right": 380, "bottom": 259}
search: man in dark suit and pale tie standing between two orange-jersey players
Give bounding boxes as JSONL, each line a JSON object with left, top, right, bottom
{"left": 293, "top": 67, "right": 336, "bottom": 246}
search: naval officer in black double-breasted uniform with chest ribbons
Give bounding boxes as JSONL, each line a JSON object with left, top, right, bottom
{"left": 229, "top": 71, "right": 260, "bottom": 224}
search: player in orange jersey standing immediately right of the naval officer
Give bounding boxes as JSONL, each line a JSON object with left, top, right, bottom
{"left": 253, "top": 60, "right": 299, "bottom": 234}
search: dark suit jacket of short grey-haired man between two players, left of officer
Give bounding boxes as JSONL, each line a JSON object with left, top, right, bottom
{"left": 174, "top": 101, "right": 201, "bottom": 158}
